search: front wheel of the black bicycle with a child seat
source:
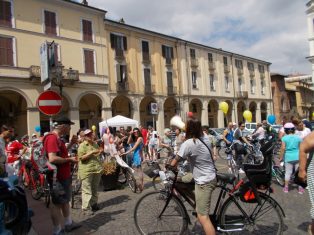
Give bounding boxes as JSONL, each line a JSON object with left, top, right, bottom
{"left": 134, "top": 192, "right": 188, "bottom": 234}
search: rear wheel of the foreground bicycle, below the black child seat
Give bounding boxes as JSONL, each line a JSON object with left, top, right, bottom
{"left": 219, "top": 193, "right": 283, "bottom": 235}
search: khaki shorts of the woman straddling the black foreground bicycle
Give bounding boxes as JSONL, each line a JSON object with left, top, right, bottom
{"left": 195, "top": 179, "right": 217, "bottom": 215}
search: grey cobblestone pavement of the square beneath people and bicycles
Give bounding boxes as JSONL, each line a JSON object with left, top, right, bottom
{"left": 29, "top": 158, "right": 310, "bottom": 235}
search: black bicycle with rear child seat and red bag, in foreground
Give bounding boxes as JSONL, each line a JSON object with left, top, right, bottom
{"left": 134, "top": 140, "right": 285, "bottom": 235}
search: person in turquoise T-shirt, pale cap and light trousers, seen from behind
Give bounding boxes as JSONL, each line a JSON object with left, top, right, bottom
{"left": 279, "top": 122, "right": 304, "bottom": 194}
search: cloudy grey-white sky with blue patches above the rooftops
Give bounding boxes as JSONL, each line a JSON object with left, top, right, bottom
{"left": 88, "top": 0, "right": 311, "bottom": 74}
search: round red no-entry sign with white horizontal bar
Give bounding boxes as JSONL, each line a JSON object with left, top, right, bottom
{"left": 37, "top": 91, "right": 62, "bottom": 116}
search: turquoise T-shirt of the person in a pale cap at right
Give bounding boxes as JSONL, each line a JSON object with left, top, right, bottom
{"left": 281, "top": 135, "right": 302, "bottom": 162}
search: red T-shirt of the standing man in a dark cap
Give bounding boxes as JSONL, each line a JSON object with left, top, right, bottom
{"left": 44, "top": 134, "right": 71, "bottom": 181}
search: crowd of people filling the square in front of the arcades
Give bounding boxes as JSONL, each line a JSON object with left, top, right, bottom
{"left": 0, "top": 114, "right": 314, "bottom": 234}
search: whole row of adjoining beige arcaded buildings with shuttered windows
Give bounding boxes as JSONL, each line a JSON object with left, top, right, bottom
{"left": 0, "top": 0, "right": 273, "bottom": 135}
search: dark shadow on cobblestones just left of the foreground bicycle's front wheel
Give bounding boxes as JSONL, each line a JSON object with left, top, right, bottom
{"left": 80, "top": 210, "right": 125, "bottom": 233}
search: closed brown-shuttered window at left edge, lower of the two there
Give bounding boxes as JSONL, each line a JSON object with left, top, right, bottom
{"left": 0, "top": 37, "right": 14, "bottom": 66}
